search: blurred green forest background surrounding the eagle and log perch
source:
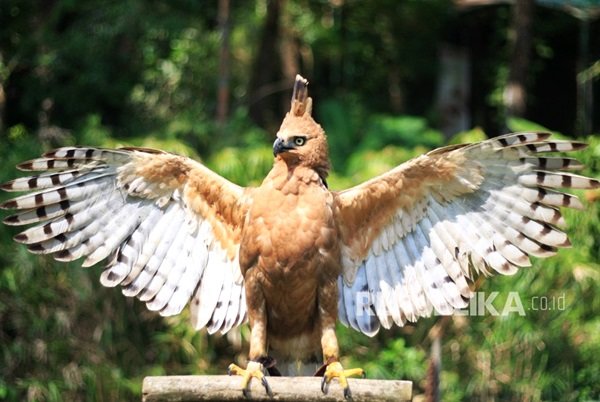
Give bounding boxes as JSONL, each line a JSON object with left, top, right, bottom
{"left": 0, "top": 0, "right": 600, "bottom": 401}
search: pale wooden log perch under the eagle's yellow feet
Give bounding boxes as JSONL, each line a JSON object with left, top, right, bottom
{"left": 142, "top": 375, "right": 412, "bottom": 402}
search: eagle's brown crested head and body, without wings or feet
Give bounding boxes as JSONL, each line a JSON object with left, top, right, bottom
{"left": 240, "top": 76, "right": 341, "bottom": 368}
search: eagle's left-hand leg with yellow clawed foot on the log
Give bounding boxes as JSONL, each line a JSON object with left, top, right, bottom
{"left": 227, "top": 281, "right": 273, "bottom": 398}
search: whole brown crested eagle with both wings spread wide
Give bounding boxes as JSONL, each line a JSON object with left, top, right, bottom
{"left": 0, "top": 75, "right": 600, "bottom": 398}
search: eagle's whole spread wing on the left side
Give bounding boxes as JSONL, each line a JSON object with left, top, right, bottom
{"left": 0, "top": 148, "right": 248, "bottom": 333}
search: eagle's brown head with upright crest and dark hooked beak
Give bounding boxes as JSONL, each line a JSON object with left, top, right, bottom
{"left": 273, "top": 75, "right": 330, "bottom": 178}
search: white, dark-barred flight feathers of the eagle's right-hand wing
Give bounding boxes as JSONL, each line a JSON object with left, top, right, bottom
{"left": 339, "top": 133, "right": 600, "bottom": 336}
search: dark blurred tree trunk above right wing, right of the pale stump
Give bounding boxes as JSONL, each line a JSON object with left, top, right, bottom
{"left": 504, "top": 0, "right": 535, "bottom": 116}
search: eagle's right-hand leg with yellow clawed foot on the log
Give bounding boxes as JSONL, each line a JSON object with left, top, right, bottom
{"left": 318, "top": 285, "right": 365, "bottom": 399}
